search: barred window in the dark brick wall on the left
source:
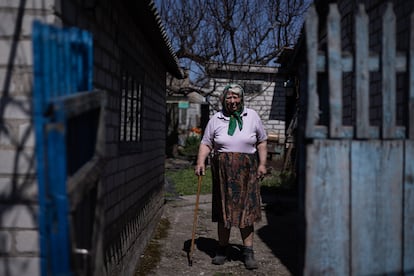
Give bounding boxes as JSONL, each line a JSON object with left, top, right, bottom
{"left": 119, "top": 70, "right": 143, "bottom": 147}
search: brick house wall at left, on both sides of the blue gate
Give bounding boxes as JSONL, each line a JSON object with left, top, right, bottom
{"left": 0, "top": 0, "right": 171, "bottom": 275}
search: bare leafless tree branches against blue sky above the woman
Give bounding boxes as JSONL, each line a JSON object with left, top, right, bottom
{"left": 158, "top": 0, "right": 310, "bottom": 93}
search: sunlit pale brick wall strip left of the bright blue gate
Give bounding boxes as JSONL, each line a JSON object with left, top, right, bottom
{"left": 0, "top": 0, "right": 54, "bottom": 276}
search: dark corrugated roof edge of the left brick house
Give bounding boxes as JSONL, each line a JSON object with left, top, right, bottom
{"left": 135, "top": 0, "right": 184, "bottom": 79}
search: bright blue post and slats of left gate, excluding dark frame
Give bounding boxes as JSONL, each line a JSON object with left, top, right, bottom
{"left": 32, "top": 21, "right": 93, "bottom": 275}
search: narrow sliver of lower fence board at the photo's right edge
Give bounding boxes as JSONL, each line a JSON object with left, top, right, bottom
{"left": 403, "top": 140, "right": 414, "bottom": 274}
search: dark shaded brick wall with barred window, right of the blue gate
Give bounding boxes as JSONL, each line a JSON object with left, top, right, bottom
{"left": 58, "top": 0, "right": 166, "bottom": 275}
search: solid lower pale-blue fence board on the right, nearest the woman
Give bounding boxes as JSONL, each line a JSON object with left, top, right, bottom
{"left": 304, "top": 140, "right": 350, "bottom": 275}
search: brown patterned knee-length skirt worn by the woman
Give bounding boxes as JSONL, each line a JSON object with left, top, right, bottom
{"left": 211, "top": 153, "right": 262, "bottom": 228}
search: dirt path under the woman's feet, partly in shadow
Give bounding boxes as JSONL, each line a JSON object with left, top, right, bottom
{"left": 137, "top": 195, "right": 299, "bottom": 276}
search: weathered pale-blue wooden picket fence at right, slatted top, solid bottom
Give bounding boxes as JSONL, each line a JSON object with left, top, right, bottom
{"left": 303, "top": 4, "right": 414, "bottom": 275}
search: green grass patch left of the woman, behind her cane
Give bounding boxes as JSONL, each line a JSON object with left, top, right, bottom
{"left": 165, "top": 167, "right": 212, "bottom": 196}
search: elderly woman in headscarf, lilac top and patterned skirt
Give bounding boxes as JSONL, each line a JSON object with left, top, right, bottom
{"left": 195, "top": 84, "right": 267, "bottom": 269}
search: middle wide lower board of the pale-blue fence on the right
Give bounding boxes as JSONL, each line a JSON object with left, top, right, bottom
{"left": 351, "top": 140, "right": 404, "bottom": 275}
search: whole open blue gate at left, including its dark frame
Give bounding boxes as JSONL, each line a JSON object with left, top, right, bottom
{"left": 32, "top": 21, "right": 104, "bottom": 275}
